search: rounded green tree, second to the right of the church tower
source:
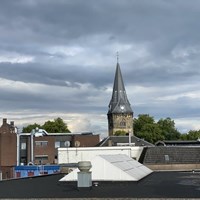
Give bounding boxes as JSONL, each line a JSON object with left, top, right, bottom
{"left": 157, "top": 117, "right": 181, "bottom": 140}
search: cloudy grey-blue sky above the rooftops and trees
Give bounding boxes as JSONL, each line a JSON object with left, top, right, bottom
{"left": 0, "top": 0, "right": 200, "bottom": 137}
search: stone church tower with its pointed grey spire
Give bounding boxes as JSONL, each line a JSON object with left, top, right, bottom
{"left": 107, "top": 62, "right": 133, "bottom": 136}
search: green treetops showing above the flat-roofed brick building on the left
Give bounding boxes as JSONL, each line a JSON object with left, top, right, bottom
{"left": 22, "top": 117, "right": 70, "bottom": 133}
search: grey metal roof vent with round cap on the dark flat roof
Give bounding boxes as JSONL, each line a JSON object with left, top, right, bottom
{"left": 77, "top": 161, "right": 92, "bottom": 189}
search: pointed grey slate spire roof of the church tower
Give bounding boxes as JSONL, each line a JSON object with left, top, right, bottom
{"left": 108, "top": 63, "right": 133, "bottom": 114}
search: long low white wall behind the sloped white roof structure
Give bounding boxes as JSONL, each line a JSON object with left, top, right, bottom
{"left": 58, "top": 146, "right": 143, "bottom": 164}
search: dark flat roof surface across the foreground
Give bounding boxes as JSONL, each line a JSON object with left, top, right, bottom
{"left": 0, "top": 172, "right": 200, "bottom": 199}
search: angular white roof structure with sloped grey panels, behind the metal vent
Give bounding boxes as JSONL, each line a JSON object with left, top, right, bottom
{"left": 60, "top": 154, "right": 152, "bottom": 181}
